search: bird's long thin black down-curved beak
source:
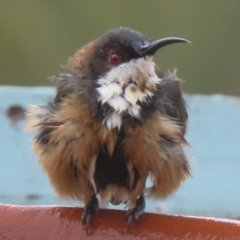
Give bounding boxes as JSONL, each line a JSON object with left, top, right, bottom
{"left": 141, "top": 37, "right": 191, "bottom": 56}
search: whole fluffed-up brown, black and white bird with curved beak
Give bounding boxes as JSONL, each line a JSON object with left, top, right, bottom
{"left": 26, "top": 27, "right": 191, "bottom": 229}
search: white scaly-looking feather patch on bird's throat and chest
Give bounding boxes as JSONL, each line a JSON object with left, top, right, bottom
{"left": 97, "top": 57, "right": 161, "bottom": 129}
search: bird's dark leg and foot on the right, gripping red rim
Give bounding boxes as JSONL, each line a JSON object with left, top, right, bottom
{"left": 127, "top": 195, "right": 146, "bottom": 226}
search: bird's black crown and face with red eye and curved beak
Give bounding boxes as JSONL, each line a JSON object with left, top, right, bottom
{"left": 88, "top": 27, "right": 188, "bottom": 78}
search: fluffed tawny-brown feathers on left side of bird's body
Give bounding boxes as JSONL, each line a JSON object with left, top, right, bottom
{"left": 27, "top": 74, "right": 117, "bottom": 203}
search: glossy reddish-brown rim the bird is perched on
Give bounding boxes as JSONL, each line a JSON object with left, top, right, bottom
{"left": 0, "top": 205, "right": 240, "bottom": 240}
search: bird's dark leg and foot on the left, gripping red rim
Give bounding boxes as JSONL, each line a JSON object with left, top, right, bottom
{"left": 82, "top": 194, "right": 99, "bottom": 228}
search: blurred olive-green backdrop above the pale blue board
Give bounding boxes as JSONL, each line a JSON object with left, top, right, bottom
{"left": 0, "top": 0, "right": 240, "bottom": 95}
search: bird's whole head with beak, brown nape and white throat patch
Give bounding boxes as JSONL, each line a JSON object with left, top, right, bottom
{"left": 65, "top": 27, "right": 188, "bottom": 129}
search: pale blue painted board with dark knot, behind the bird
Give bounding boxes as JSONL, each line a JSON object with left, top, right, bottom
{"left": 0, "top": 87, "right": 240, "bottom": 218}
